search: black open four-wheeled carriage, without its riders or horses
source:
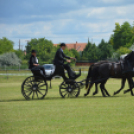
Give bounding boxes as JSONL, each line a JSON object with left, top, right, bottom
{"left": 21, "top": 65, "right": 83, "bottom": 100}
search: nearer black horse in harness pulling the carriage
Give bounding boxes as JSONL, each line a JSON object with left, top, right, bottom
{"left": 84, "top": 51, "right": 134, "bottom": 96}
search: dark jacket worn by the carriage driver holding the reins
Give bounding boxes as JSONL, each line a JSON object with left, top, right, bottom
{"left": 54, "top": 48, "right": 70, "bottom": 65}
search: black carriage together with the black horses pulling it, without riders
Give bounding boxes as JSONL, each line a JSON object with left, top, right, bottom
{"left": 21, "top": 51, "right": 134, "bottom": 99}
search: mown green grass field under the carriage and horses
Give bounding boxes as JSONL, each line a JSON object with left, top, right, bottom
{"left": 0, "top": 76, "right": 134, "bottom": 134}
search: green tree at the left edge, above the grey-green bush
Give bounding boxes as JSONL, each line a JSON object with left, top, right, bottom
{"left": 0, "top": 37, "right": 14, "bottom": 54}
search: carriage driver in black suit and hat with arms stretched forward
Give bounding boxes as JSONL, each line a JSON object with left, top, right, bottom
{"left": 54, "top": 43, "right": 81, "bottom": 79}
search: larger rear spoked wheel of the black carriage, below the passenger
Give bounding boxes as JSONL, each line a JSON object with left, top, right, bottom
{"left": 21, "top": 76, "right": 48, "bottom": 100}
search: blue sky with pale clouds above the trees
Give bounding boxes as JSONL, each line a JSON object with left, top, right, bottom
{"left": 0, "top": 0, "right": 134, "bottom": 50}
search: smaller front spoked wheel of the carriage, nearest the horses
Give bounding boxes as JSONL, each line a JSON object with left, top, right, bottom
{"left": 59, "top": 81, "right": 80, "bottom": 98}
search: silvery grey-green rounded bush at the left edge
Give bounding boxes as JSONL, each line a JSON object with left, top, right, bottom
{"left": 0, "top": 52, "right": 21, "bottom": 66}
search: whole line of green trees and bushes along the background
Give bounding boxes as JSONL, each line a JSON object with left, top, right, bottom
{"left": 0, "top": 22, "right": 134, "bottom": 65}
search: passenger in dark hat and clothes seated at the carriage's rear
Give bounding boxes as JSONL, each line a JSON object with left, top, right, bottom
{"left": 29, "top": 50, "right": 45, "bottom": 75}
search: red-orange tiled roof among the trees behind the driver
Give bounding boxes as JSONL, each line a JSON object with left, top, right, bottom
{"left": 54, "top": 42, "right": 87, "bottom": 52}
